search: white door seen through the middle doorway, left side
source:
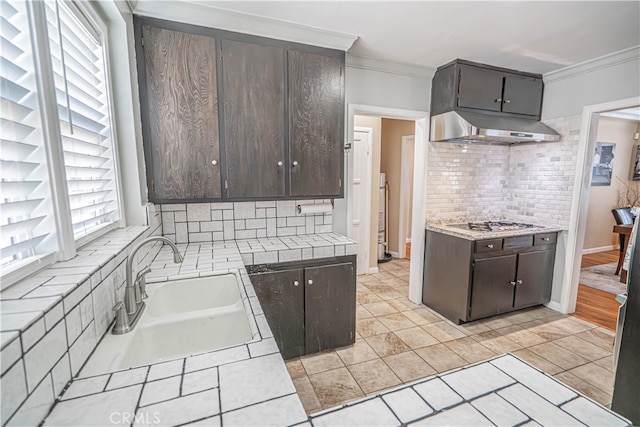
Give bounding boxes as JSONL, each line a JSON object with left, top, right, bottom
{"left": 351, "top": 127, "right": 373, "bottom": 274}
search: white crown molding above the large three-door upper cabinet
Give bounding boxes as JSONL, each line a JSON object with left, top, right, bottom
{"left": 129, "top": 0, "right": 358, "bottom": 51}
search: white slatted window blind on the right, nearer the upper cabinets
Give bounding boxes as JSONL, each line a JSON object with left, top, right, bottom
{"left": 46, "top": 0, "right": 119, "bottom": 240}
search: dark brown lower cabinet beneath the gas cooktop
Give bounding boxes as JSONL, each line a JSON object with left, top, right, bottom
{"left": 422, "top": 230, "right": 557, "bottom": 324}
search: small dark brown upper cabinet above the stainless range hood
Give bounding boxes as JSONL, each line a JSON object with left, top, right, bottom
{"left": 431, "top": 59, "right": 544, "bottom": 120}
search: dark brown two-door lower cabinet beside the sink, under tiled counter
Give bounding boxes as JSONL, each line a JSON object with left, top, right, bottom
{"left": 248, "top": 256, "right": 356, "bottom": 359}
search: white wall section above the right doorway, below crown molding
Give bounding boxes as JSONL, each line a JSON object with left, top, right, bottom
{"left": 542, "top": 47, "right": 640, "bottom": 120}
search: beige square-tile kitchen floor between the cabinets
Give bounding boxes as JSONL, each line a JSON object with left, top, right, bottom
{"left": 286, "top": 260, "right": 614, "bottom": 413}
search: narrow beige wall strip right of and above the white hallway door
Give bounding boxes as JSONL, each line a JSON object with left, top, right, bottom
{"left": 353, "top": 116, "right": 382, "bottom": 268}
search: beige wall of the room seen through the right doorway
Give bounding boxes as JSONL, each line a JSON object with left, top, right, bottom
{"left": 584, "top": 116, "right": 638, "bottom": 249}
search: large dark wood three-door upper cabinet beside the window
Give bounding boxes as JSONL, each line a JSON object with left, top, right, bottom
{"left": 134, "top": 16, "right": 345, "bottom": 203}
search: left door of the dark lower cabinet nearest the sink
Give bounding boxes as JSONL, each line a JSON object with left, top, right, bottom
{"left": 251, "top": 269, "right": 305, "bottom": 359}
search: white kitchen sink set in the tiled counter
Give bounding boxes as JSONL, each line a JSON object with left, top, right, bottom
{"left": 81, "top": 274, "right": 253, "bottom": 377}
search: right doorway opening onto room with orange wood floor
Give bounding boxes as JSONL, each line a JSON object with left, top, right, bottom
{"left": 574, "top": 109, "right": 640, "bottom": 330}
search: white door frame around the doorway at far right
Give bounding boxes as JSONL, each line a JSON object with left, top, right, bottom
{"left": 564, "top": 97, "right": 639, "bottom": 313}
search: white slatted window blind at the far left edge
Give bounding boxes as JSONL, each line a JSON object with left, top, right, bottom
{"left": 0, "top": 0, "right": 52, "bottom": 269}
